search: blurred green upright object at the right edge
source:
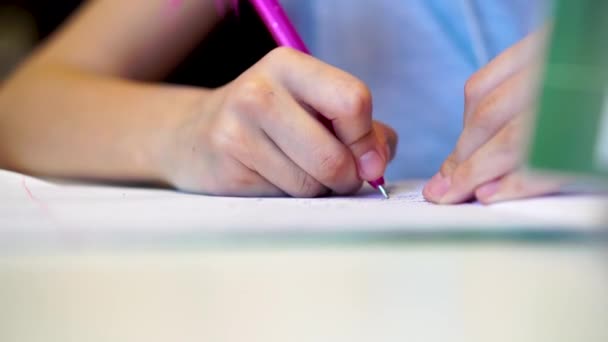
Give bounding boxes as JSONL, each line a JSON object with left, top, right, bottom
{"left": 529, "top": 0, "right": 608, "bottom": 175}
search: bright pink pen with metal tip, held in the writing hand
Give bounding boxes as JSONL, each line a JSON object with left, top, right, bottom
{"left": 249, "top": 0, "right": 389, "bottom": 199}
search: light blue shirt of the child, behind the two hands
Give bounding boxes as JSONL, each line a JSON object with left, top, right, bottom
{"left": 281, "top": 0, "right": 544, "bottom": 179}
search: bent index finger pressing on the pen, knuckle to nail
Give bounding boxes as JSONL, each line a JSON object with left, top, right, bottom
{"left": 267, "top": 48, "right": 388, "bottom": 181}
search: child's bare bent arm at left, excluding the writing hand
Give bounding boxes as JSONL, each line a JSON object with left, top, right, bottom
{"left": 0, "top": 0, "right": 218, "bottom": 181}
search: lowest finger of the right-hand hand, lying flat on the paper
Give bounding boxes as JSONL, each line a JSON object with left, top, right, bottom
{"left": 475, "top": 170, "right": 566, "bottom": 204}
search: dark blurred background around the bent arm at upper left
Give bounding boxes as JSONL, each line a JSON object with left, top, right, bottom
{"left": 0, "top": 0, "right": 275, "bottom": 87}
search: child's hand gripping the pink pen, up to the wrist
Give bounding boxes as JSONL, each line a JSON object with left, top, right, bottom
{"left": 164, "top": 48, "right": 396, "bottom": 197}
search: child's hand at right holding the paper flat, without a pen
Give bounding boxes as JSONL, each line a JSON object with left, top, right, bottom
{"left": 424, "top": 31, "right": 559, "bottom": 204}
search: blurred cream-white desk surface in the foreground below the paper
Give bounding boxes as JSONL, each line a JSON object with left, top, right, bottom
{"left": 0, "top": 243, "right": 608, "bottom": 342}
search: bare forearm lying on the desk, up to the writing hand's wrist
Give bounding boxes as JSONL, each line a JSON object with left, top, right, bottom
{"left": 0, "top": 62, "right": 208, "bottom": 182}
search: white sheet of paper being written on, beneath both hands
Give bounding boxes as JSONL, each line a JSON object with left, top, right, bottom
{"left": 0, "top": 170, "right": 608, "bottom": 246}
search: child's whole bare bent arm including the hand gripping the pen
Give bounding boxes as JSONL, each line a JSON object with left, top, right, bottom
{"left": 0, "top": 0, "right": 396, "bottom": 196}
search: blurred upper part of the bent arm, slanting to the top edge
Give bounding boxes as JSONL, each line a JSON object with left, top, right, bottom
{"left": 39, "top": 0, "right": 220, "bottom": 80}
